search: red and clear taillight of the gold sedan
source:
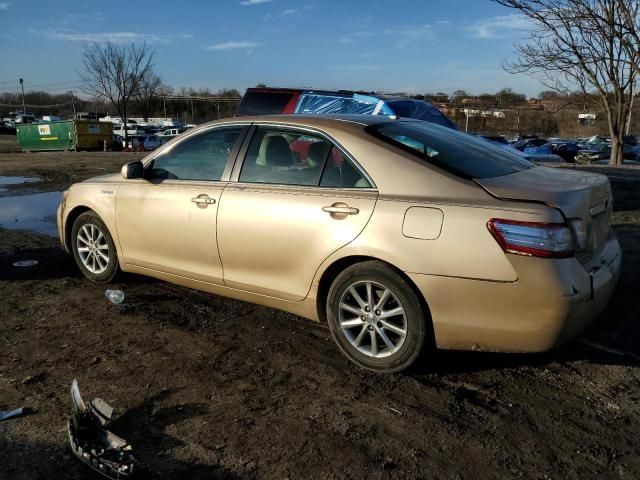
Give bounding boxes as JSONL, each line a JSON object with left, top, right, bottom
{"left": 487, "top": 218, "right": 575, "bottom": 258}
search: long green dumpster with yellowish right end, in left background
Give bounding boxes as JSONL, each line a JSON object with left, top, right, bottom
{"left": 16, "top": 120, "right": 113, "bottom": 151}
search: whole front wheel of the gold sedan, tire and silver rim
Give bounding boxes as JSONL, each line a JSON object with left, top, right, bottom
{"left": 70, "top": 212, "right": 118, "bottom": 283}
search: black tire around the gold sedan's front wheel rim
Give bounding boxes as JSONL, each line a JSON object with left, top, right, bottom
{"left": 69, "top": 211, "right": 119, "bottom": 283}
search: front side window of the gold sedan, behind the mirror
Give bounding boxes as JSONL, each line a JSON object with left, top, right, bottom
{"left": 149, "top": 126, "right": 244, "bottom": 181}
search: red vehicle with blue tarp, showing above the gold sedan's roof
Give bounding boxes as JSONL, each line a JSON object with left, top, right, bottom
{"left": 236, "top": 87, "right": 458, "bottom": 130}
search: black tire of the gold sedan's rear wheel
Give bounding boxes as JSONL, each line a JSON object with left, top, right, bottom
{"left": 326, "top": 261, "right": 430, "bottom": 373}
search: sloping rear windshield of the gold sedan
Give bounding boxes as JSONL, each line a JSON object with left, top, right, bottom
{"left": 367, "top": 121, "right": 535, "bottom": 178}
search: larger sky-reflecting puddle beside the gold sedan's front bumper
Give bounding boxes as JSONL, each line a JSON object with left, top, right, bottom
{"left": 0, "top": 191, "right": 61, "bottom": 237}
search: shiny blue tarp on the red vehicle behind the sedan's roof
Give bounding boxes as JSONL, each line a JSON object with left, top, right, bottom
{"left": 295, "top": 91, "right": 458, "bottom": 130}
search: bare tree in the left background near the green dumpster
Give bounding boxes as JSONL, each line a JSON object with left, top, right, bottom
{"left": 81, "top": 42, "right": 154, "bottom": 140}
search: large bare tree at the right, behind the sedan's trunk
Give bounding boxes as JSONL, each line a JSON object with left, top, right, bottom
{"left": 493, "top": 0, "right": 638, "bottom": 164}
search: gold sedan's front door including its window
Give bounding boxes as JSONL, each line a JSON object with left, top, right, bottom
{"left": 116, "top": 126, "right": 245, "bottom": 284}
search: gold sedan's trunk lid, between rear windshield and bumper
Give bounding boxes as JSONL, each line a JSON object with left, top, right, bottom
{"left": 475, "top": 167, "right": 613, "bottom": 264}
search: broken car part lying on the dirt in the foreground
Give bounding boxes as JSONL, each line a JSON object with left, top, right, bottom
{"left": 69, "top": 380, "right": 136, "bottom": 480}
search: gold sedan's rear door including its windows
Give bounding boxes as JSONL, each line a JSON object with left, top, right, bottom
{"left": 218, "top": 125, "right": 378, "bottom": 300}
